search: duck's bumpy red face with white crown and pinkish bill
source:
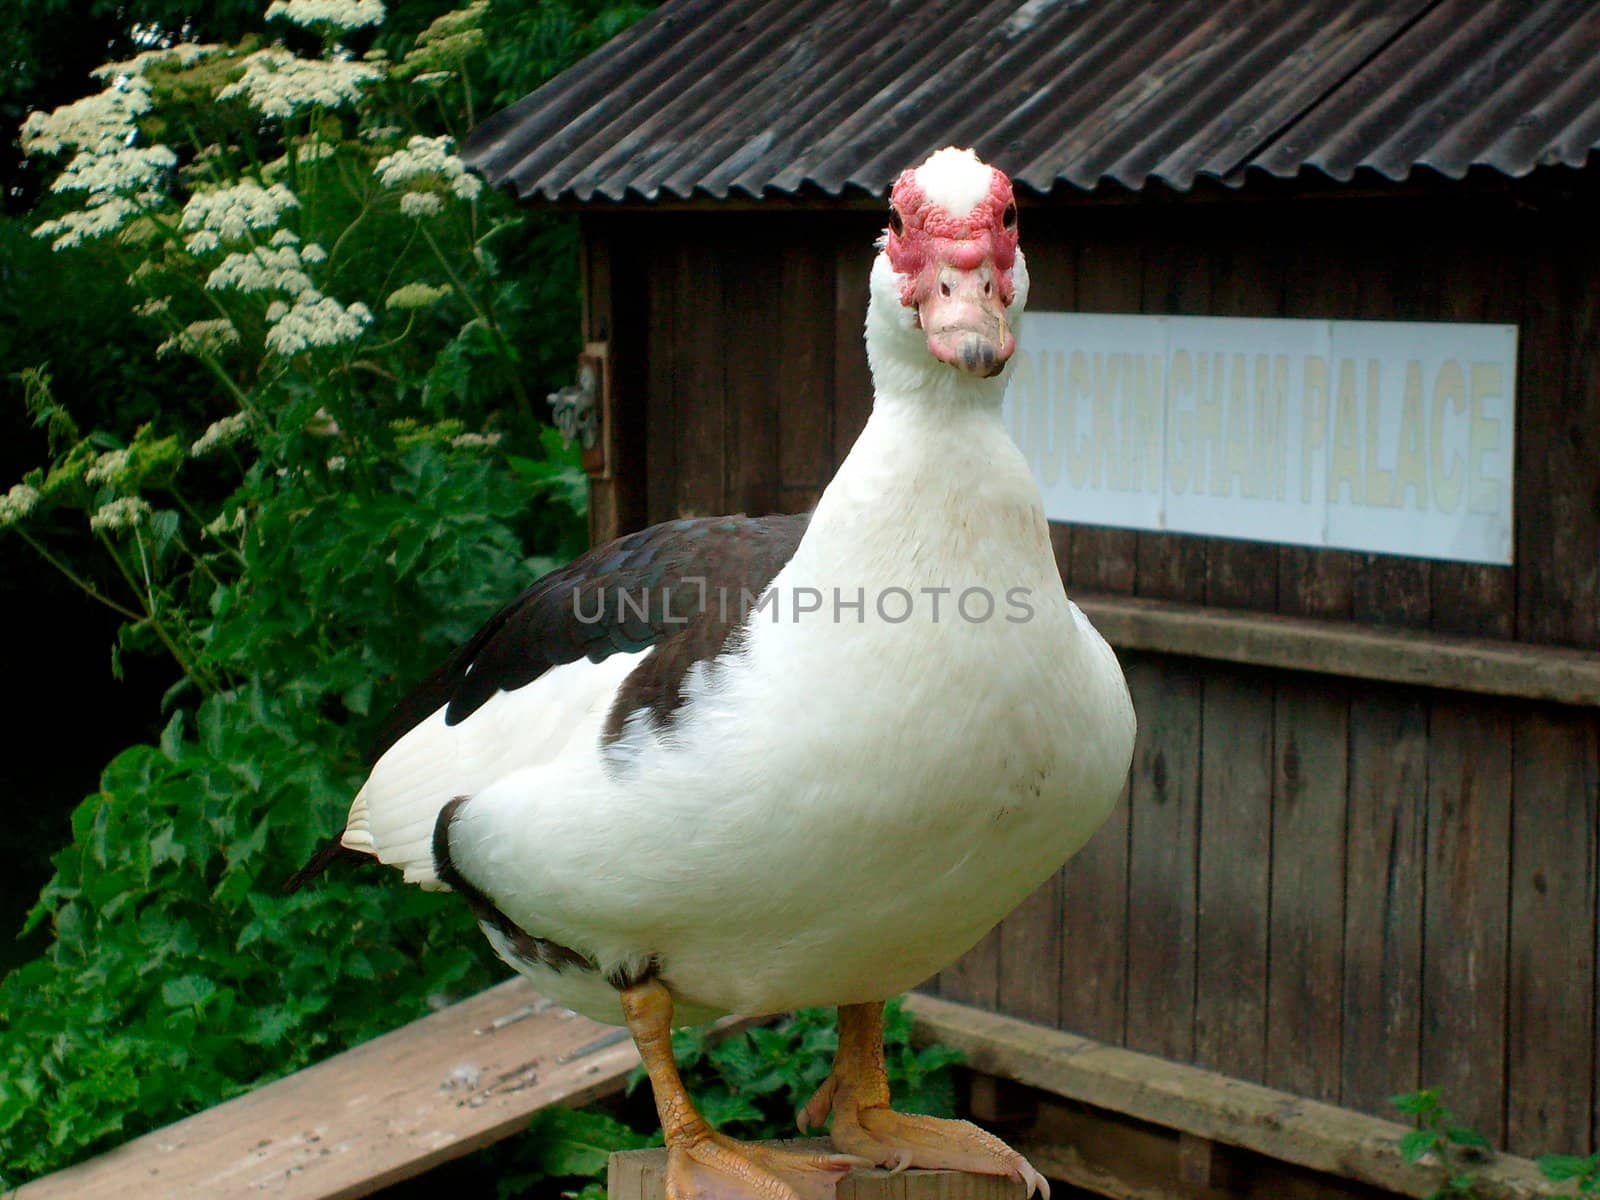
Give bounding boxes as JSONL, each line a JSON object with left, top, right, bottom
{"left": 883, "top": 150, "right": 1016, "bottom": 376}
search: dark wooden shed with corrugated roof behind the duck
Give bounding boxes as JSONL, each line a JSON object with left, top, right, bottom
{"left": 469, "top": 0, "right": 1600, "bottom": 1195}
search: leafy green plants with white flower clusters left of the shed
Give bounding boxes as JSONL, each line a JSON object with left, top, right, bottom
{"left": 0, "top": 0, "right": 582, "bottom": 1187}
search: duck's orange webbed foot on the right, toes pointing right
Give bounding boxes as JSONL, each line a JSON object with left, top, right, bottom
{"left": 808, "top": 1104, "right": 1050, "bottom": 1200}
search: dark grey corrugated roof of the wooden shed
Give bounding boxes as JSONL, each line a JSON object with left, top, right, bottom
{"left": 466, "top": 0, "right": 1600, "bottom": 202}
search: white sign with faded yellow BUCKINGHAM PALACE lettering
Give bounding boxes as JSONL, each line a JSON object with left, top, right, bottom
{"left": 1005, "top": 312, "right": 1517, "bottom": 563}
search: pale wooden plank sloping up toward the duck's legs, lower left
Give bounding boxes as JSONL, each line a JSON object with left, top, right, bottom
{"left": 14, "top": 979, "right": 638, "bottom": 1200}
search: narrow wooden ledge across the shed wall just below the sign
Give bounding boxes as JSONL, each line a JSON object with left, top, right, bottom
{"left": 1074, "top": 595, "right": 1600, "bottom": 707}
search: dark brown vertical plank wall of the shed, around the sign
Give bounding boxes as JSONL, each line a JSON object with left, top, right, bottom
{"left": 589, "top": 194, "right": 1600, "bottom": 1154}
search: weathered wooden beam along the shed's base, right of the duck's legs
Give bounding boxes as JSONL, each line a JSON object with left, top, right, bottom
{"left": 906, "top": 995, "right": 1566, "bottom": 1200}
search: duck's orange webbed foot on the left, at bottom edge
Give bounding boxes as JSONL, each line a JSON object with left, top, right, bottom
{"left": 667, "top": 1131, "right": 872, "bottom": 1200}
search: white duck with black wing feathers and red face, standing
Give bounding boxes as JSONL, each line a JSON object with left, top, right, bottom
{"left": 315, "top": 149, "right": 1134, "bottom": 1200}
